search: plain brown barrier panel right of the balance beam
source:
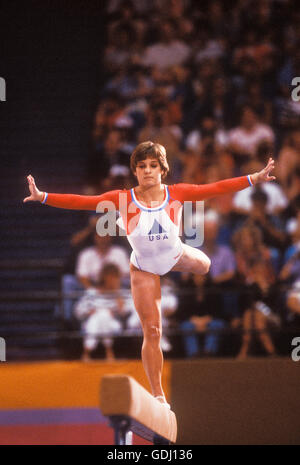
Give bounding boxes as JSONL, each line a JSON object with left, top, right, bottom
{"left": 171, "top": 359, "right": 300, "bottom": 445}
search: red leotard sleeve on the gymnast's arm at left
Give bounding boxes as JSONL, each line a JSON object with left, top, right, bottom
{"left": 45, "top": 189, "right": 128, "bottom": 211}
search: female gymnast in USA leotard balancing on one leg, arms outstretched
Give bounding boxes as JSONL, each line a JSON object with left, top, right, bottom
{"left": 24, "top": 141, "right": 275, "bottom": 407}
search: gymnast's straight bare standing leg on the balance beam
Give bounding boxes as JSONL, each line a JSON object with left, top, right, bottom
{"left": 130, "top": 263, "right": 164, "bottom": 397}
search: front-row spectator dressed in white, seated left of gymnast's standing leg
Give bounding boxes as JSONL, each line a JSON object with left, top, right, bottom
{"left": 75, "top": 263, "right": 134, "bottom": 361}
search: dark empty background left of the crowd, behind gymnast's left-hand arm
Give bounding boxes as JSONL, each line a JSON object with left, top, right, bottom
{"left": 0, "top": 0, "right": 105, "bottom": 359}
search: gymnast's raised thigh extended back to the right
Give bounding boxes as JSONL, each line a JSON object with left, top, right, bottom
{"left": 171, "top": 244, "right": 210, "bottom": 274}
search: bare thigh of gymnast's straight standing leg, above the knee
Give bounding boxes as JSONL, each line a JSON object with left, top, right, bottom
{"left": 130, "top": 263, "right": 161, "bottom": 326}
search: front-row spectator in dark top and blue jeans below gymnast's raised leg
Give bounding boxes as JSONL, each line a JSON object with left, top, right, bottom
{"left": 176, "top": 273, "right": 226, "bottom": 357}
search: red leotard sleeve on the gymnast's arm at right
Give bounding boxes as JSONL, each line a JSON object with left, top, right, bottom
{"left": 169, "top": 176, "right": 250, "bottom": 202}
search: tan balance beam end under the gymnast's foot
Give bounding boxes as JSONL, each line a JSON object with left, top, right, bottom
{"left": 100, "top": 375, "right": 177, "bottom": 445}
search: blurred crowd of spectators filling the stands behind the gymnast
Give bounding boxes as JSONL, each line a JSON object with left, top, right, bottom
{"left": 63, "top": 0, "right": 300, "bottom": 358}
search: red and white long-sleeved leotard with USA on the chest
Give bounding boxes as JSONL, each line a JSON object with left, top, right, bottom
{"left": 43, "top": 176, "right": 252, "bottom": 275}
